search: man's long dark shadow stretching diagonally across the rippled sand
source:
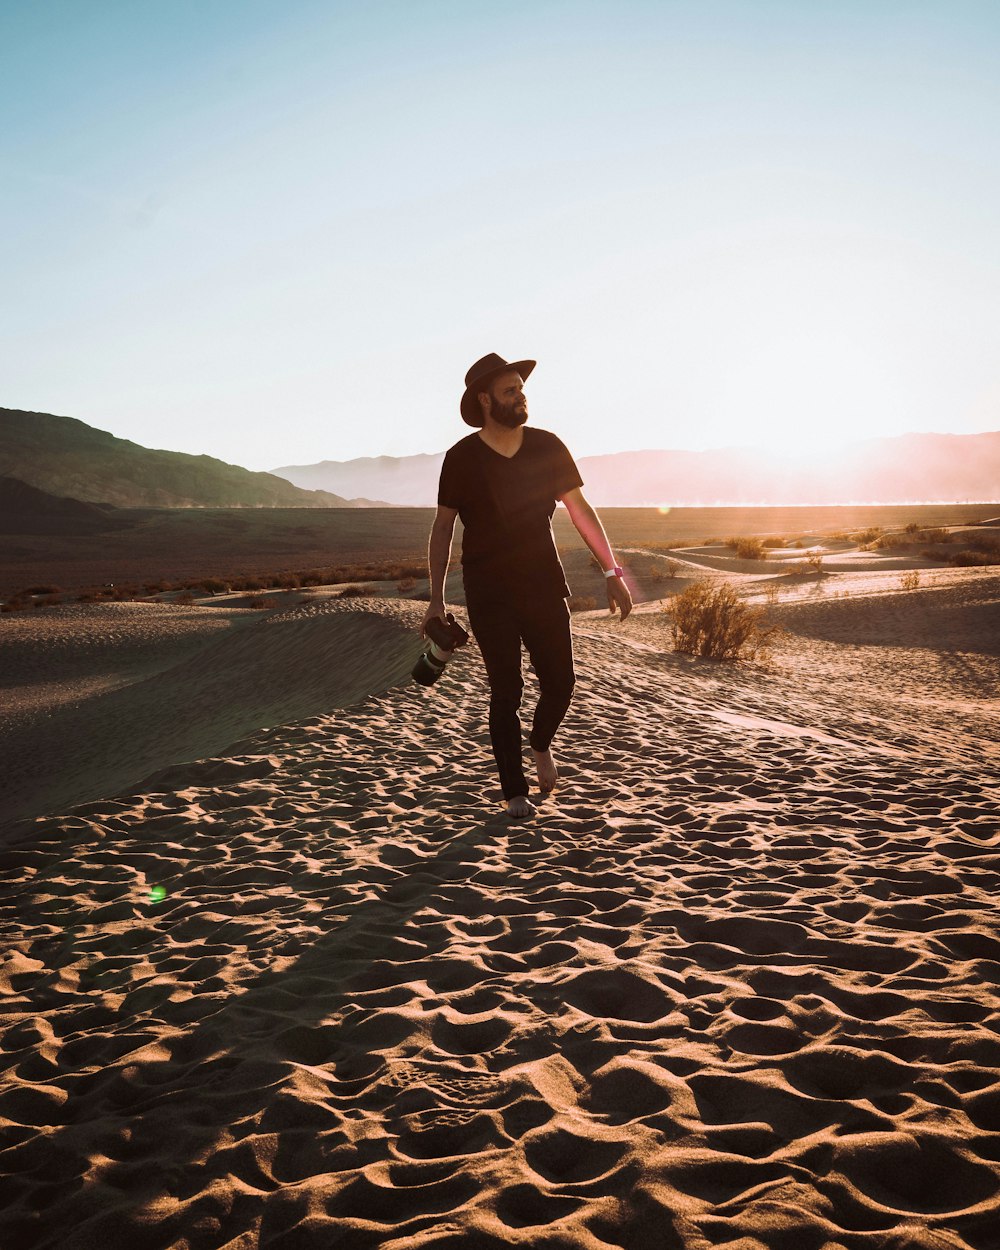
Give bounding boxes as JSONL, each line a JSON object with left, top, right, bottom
{"left": 0, "top": 819, "right": 527, "bottom": 1250}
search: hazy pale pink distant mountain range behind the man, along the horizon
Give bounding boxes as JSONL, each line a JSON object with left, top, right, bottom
{"left": 274, "top": 433, "right": 1000, "bottom": 508}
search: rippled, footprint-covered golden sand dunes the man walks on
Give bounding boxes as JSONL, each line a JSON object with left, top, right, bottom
{"left": 0, "top": 562, "right": 1000, "bottom": 1250}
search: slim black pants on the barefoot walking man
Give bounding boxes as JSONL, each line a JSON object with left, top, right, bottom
{"left": 466, "top": 594, "right": 576, "bottom": 799}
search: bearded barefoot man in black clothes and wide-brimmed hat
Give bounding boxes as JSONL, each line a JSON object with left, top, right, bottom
{"left": 421, "top": 353, "right": 633, "bottom": 819}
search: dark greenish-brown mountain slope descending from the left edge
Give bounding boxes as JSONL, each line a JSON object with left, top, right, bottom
{"left": 0, "top": 408, "right": 368, "bottom": 508}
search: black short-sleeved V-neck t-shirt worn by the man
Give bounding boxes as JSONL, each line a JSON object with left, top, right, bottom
{"left": 438, "top": 426, "right": 584, "bottom": 598}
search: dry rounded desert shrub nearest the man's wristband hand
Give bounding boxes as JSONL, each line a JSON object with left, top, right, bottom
{"left": 666, "top": 581, "right": 781, "bottom": 660}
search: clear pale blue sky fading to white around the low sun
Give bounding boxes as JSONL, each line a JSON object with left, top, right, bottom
{"left": 0, "top": 0, "right": 1000, "bottom": 469}
